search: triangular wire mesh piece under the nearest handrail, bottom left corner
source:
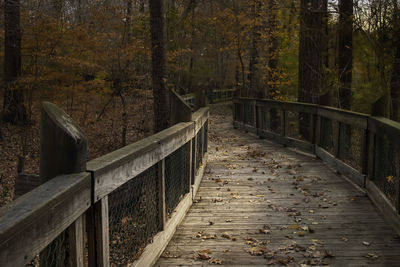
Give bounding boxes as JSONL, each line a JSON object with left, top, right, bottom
{"left": 36, "top": 229, "right": 69, "bottom": 267}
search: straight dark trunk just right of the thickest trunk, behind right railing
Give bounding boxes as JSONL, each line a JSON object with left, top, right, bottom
{"left": 338, "top": 0, "right": 353, "bottom": 109}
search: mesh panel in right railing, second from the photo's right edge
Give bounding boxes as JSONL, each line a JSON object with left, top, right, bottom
{"left": 338, "top": 123, "right": 364, "bottom": 172}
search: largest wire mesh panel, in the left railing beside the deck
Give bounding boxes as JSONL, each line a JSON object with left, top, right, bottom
{"left": 108, "top": 165, "right": 160, "bottom": 266}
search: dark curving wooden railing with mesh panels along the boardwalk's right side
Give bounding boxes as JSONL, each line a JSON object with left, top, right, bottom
{"left": 233, "top": 98, "right": 400, "bottom": 233}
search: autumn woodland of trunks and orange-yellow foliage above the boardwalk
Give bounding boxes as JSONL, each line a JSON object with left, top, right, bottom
{"left": 2, "top": 0, "right": 400, "bottom": 126}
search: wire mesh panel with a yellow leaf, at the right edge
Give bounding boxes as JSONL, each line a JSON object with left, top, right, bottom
{"left": 373, "top": 135, "right": 400, "bottom": 207}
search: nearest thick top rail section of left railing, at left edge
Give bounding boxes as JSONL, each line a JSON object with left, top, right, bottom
{"left": 0, "top": 173, "right": 91, "bottom": 266}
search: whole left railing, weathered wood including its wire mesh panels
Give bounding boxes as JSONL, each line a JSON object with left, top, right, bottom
{"left": 0, "top": 103, "right": 209, "bottom": 267}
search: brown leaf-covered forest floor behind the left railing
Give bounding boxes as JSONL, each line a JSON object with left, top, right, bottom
{"left": 0, "top": 90, "right": 153, "bottom": 207}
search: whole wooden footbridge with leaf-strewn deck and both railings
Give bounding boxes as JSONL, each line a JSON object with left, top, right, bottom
{"left": 0, "top": 99, "right": 400, "bottom": 266}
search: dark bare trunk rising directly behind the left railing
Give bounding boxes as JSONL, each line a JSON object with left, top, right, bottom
{"left": 149, "top": 0, "right": 170, "bottom": 132}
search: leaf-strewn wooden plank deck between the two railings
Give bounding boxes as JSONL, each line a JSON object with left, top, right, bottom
{"left": 155, "top": 105, "right": 400, "bottom": 266}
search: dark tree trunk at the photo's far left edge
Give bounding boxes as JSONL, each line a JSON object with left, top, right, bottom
{"left": 3, "top": 0, "right": 27, "bottom": 123}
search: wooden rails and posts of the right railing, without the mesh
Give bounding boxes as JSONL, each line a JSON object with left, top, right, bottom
{"left": 233, "top": 98, "right": 400, "bottom": 236}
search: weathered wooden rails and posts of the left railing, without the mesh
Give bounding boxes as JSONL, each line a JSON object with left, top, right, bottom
{"left": 0, "top": 102, "right": 209, "bottom": 266}
